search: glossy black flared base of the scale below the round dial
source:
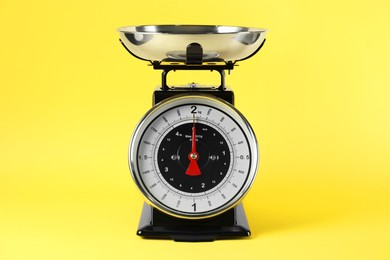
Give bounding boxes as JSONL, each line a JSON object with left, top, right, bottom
{"left": 137, "top": 203, "right": 250, "bottom": 242}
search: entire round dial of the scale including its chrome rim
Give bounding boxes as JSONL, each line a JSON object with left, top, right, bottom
{"left": 129, "top": 95, "right": 258, "bottom": 219}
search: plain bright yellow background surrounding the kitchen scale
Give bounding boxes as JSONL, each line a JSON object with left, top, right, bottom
{"left": 0, "top": 0, "right": 390, "bottom": 260}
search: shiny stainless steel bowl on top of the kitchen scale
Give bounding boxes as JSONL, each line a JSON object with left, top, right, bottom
{"left": 118, "top": 25, "right": 267, "bottom": 62}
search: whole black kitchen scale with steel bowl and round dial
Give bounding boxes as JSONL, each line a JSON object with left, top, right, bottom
{"left": 118, "top": 25, "right": 266, "bottom": 241}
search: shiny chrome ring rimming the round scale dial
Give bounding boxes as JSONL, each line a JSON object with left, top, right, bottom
{"left": 128, "top": 94, "right": 260, "bottom": 219}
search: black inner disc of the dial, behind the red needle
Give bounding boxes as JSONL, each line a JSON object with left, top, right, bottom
{"left": 157, "top": 123, "right": 230, "bottom": 193}
